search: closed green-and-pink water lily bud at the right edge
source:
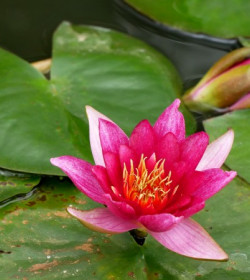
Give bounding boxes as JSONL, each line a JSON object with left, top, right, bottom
{"left": 183, "top": 47, "right": 250, "bottom": 112}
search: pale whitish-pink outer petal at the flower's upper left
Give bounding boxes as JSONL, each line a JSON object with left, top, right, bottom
{"left": 86, "top": 106, "right": 112, "bottom": 166}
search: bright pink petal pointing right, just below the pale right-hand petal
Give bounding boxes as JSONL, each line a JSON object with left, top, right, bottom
{"left": 191, "top": 168, "right": 237, "bottom": 200}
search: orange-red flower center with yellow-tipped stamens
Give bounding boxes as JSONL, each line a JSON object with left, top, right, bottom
{"left": 123, "top": 155, "right": 179, "bottom": 210}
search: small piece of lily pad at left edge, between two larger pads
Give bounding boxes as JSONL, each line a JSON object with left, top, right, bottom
{"left": 0, "top": 170, "right": 41, "bottom": 203}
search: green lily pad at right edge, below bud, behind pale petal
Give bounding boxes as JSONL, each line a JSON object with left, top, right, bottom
{"left": 203, "top": 109, "right": 250, "bottom": 182}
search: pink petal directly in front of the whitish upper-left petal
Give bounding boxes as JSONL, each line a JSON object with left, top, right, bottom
{"left": 99, "top": 119, "right": 128, "bottom": 154}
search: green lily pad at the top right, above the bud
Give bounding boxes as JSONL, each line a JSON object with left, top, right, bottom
{"left": 124, "top": 0, "right": 250, "bottom": 38}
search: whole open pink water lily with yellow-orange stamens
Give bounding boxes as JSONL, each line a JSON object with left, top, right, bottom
{"left": 51, "top": 99, "right": 236, "bottom": 260}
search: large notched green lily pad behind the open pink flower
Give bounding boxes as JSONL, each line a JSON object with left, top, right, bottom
{"left": 0, "top": 23, "right": 194, "bottom": 174}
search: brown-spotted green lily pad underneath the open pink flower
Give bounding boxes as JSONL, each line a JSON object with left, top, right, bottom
{"left": 0, "top": 175, "right": 250, "bottom": 280}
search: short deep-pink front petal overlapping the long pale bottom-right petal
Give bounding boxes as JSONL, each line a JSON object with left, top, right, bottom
{"left": 138, "top": 213, "right": 182, "bottom": 232}
